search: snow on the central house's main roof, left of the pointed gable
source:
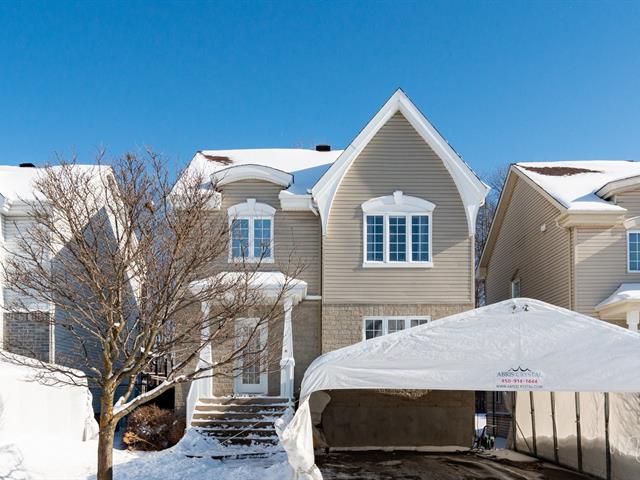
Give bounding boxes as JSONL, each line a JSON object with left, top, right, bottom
{"left": 180, "top": 148, "right": 342, "bottom": 194}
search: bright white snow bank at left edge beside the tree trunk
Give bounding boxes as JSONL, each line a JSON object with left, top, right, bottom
{"left": 0, "top": 351, "right": 98, "bottom": 444}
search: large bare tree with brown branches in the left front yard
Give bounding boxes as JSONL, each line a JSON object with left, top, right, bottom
{"left": 5, "top": 152, "right": 301, "bottom": 480}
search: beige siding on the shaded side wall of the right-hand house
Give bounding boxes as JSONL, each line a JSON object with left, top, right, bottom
{"left": 486, "top": 174, "right": 571, "bottom": 308}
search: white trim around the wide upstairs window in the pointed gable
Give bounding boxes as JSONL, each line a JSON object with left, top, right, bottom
{"left": 362, "top": 190, "right": 436, "bottom": 268}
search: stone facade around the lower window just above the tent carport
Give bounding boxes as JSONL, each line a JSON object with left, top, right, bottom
{"left": 322, "top": 303, "right": 474, "bottom": 353}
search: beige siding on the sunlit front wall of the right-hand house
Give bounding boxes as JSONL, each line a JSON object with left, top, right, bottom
{"left": 576, "top": 191, "right": 640, "bottom": 327}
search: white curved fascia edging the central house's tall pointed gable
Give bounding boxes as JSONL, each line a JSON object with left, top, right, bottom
{"left": 312, "top": 89, "right": 490, "bottom": 235}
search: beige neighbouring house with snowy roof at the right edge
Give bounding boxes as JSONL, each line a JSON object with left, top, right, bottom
{"left": 478, "top": 161, "right": 640, "bottom": 436}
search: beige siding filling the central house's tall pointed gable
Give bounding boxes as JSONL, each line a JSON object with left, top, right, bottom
{"left": 323, "top": 113, "right": 474, "bottom": 304}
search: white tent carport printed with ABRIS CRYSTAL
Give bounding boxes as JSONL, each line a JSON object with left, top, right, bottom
{"left": 278, "top": 298, "right": 640, "bottom": 480}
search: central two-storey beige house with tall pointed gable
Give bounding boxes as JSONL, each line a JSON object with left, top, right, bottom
{"left": 178, "top": 90, "right": 488, "bottom": 445}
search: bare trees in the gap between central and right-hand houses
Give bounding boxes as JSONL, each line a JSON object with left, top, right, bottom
{"left": 475, "top": 165, "right": 509, "bottom": 306}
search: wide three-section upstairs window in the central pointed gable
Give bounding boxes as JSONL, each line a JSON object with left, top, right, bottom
{"left": 362, "top": 192, "right": 435, "bottom": 267}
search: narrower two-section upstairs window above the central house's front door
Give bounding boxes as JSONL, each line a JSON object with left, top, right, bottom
{"left": 228, "top": 198, "right": 275, "bottom": 262}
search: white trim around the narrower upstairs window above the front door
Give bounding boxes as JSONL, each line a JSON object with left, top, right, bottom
{"left": 227, "top": 198, "right": 276, "bottom": 263}
